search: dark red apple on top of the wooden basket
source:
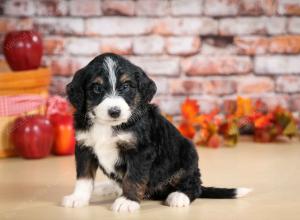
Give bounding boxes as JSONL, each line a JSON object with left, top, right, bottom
{"left": 3, "top": 31, "right": 43, "bottom": 71}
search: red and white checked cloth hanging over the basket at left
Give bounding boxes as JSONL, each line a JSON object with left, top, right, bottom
{"left": 0, "top": 95, "right": 47, "bottom": 117}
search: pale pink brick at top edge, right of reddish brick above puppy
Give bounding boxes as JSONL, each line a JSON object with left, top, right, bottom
{"left": 136, "top": 0, "right": 170, "bottom": 16}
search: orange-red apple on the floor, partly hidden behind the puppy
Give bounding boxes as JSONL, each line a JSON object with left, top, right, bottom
{"left": 50, "top": 114, "right": 75, "bottom": 155}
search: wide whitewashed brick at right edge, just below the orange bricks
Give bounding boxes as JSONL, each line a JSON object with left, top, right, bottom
{"left": 254, "top": 55, "right": 300, "bottom": 74}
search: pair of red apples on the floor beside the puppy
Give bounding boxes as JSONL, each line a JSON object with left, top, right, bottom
{"left": 10, "top": 97, "right": 75, "bottom": 159}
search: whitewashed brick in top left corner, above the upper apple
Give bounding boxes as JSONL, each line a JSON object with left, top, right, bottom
{"left": 4, "top": 0, "right": 36, "bottom": 16}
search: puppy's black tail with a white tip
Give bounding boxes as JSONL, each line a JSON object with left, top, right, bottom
{"left": 200, "top": 186, "right": 252, "bottom": 199}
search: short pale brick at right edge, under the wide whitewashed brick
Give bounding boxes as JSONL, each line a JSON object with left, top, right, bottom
{"left": 276, "top": 76, "right": 300, "bottom": 93}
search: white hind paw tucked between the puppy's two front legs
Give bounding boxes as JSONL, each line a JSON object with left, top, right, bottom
{"left": 94, "top": 181, "right": 122, "bottom": 196}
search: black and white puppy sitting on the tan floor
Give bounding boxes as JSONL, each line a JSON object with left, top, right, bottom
{"left": 62, "top": 53, "right": 250, "bottom": 211}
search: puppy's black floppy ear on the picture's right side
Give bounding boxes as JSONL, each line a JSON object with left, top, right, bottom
{"left": 137, "top": 68, "right": 157, "bottom": 103}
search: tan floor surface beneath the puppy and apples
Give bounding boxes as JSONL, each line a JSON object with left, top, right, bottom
{"left": 0, "top": 141, "right": 300, "bottom": 220}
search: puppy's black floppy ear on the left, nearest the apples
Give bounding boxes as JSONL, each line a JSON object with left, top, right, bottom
{"left": 66, "top": 69, "right": 84, "bottom": 111}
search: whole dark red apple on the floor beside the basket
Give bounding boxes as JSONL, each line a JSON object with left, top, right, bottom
{"left": 11, "top": 115, "right": 54, "bottom": 159}
